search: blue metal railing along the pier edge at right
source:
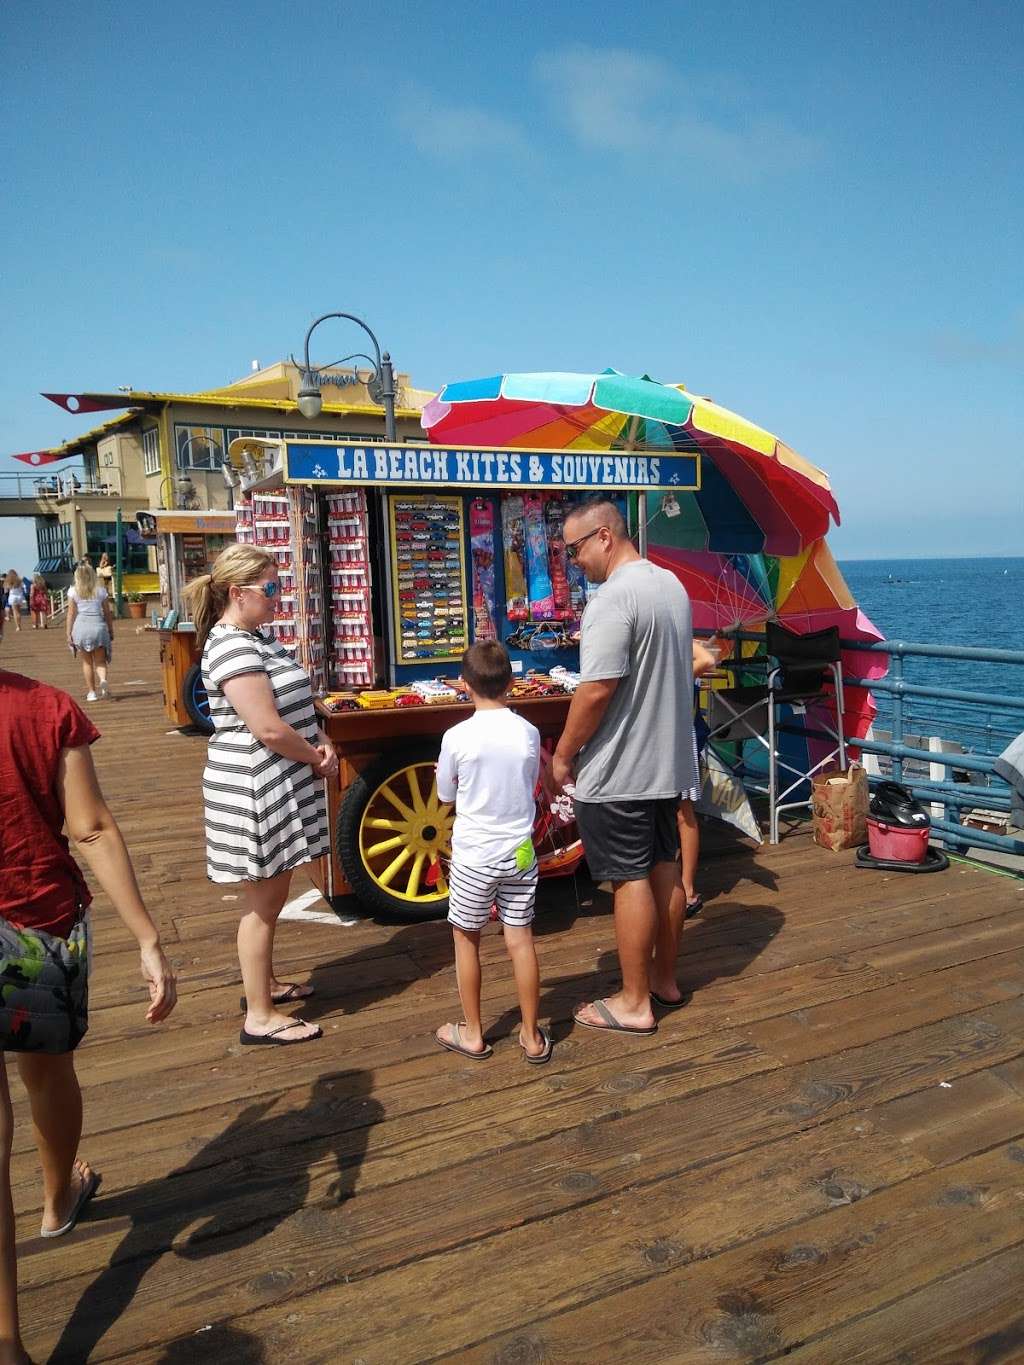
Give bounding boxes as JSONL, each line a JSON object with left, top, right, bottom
{"left": 706, "top": 631, "right": 1024, "bottom": 857}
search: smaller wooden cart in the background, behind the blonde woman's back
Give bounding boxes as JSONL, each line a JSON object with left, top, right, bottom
{"left": 137, "top": 511, "right": 235, "bottom": 734}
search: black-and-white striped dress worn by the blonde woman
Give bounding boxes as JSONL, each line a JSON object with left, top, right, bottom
{"left": 202, "top": 622, "right": 330, "bottom": 882}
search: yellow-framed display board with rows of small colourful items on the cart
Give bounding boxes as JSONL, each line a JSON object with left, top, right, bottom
{"left": 389, "top": 495, "right": 470, "bottom": 663}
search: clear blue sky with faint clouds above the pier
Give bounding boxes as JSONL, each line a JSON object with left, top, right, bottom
{"left": 0, "top": 0, "right": 1024, "bottom": 566}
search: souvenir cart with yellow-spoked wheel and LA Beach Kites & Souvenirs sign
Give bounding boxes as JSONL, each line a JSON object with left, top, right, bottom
{"left": 229, "top": 438, "right": 698, "bottom": 919}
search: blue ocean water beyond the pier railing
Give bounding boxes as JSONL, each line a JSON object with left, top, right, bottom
{"left": 840, "top": 558, "right": 1024, "bottom": 752}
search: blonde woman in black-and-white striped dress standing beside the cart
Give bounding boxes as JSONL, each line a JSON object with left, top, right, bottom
{"left": 184, "top": 545, "right": 337, "bottom": 1044}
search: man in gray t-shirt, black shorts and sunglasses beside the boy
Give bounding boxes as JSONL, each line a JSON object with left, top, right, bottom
{"left": 552, "top": 498, "right": 698, "bottom": 1035}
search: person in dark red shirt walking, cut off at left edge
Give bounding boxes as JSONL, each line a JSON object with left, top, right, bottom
{"left": 0, "top": 624, "right": 176, "bottom": 1365}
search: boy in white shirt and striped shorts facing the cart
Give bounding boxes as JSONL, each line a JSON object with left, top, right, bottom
{"left": 434, "top": 640, "right": 552, "bottom": 1066}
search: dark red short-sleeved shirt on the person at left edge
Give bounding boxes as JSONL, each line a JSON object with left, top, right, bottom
{"left": 0, "top": 669, "right": 100, "bottom": 938}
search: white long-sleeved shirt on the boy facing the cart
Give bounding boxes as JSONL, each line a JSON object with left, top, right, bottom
{"left": 437, "top": 706, "right": 541, "bottom": 867}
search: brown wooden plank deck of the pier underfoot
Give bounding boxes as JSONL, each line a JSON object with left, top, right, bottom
{"left": 0, "top": 622, "right": 1024, "bottom": 1365}
